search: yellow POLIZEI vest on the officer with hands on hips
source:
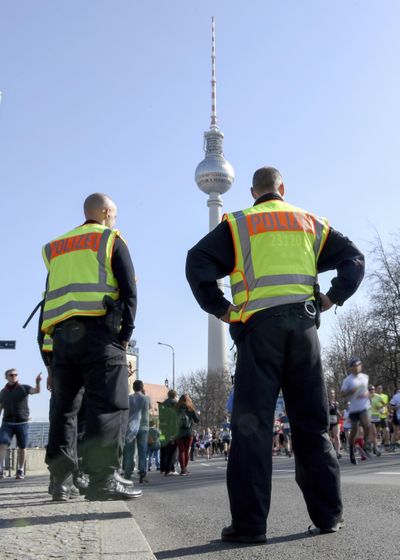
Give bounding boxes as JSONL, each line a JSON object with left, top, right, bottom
{"left": 223, "top": 199, "right": 329, "bottom": 323}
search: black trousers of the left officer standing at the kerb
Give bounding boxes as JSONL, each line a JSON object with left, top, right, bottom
{"left": 46, "top": 317, "right": 128, "bottom": 482}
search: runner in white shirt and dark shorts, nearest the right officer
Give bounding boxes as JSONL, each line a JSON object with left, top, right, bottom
{"left": 341, "top": 357, "right": 371, "bottom": 465}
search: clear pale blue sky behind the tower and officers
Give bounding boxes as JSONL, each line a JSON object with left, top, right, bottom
{"left": 0, "top": 0, "right": 400, "bottom": 419}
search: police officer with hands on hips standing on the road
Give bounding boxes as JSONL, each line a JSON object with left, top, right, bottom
{"left": 186, "top": 167, "right": 364, "bottom": 543}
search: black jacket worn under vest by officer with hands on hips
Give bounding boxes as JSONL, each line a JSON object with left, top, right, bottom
{"left": 186, "top": 193, "right": 365, "bottom": 341}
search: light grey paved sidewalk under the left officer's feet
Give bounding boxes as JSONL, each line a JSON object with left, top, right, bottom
{"left": 0, "top": 475, "right": 155, "bottom": 560}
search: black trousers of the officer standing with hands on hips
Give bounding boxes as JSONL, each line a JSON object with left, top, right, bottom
{"left": 227, "top": 304, "right": 342, "bottom": 534}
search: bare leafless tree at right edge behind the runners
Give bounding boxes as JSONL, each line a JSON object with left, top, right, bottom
{"left": 323, "top": 230, "right": 400, "bottom": 394}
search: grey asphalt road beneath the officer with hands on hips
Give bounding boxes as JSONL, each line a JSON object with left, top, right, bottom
{"left": 128, "top": 453, "right": 400, "bottom": 560}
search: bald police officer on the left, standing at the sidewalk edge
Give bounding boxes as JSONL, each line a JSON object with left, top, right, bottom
{"left": 40, "top": 193, "right": 141, "bottom": 501}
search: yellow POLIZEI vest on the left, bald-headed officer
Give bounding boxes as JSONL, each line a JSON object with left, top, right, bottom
{"left": 41, "top": 223, "right": 119, "bottom": 334}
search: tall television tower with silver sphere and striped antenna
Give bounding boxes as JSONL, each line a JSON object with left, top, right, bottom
{"left": 195, "top": 17, "right": 235, "bottom": 373}
